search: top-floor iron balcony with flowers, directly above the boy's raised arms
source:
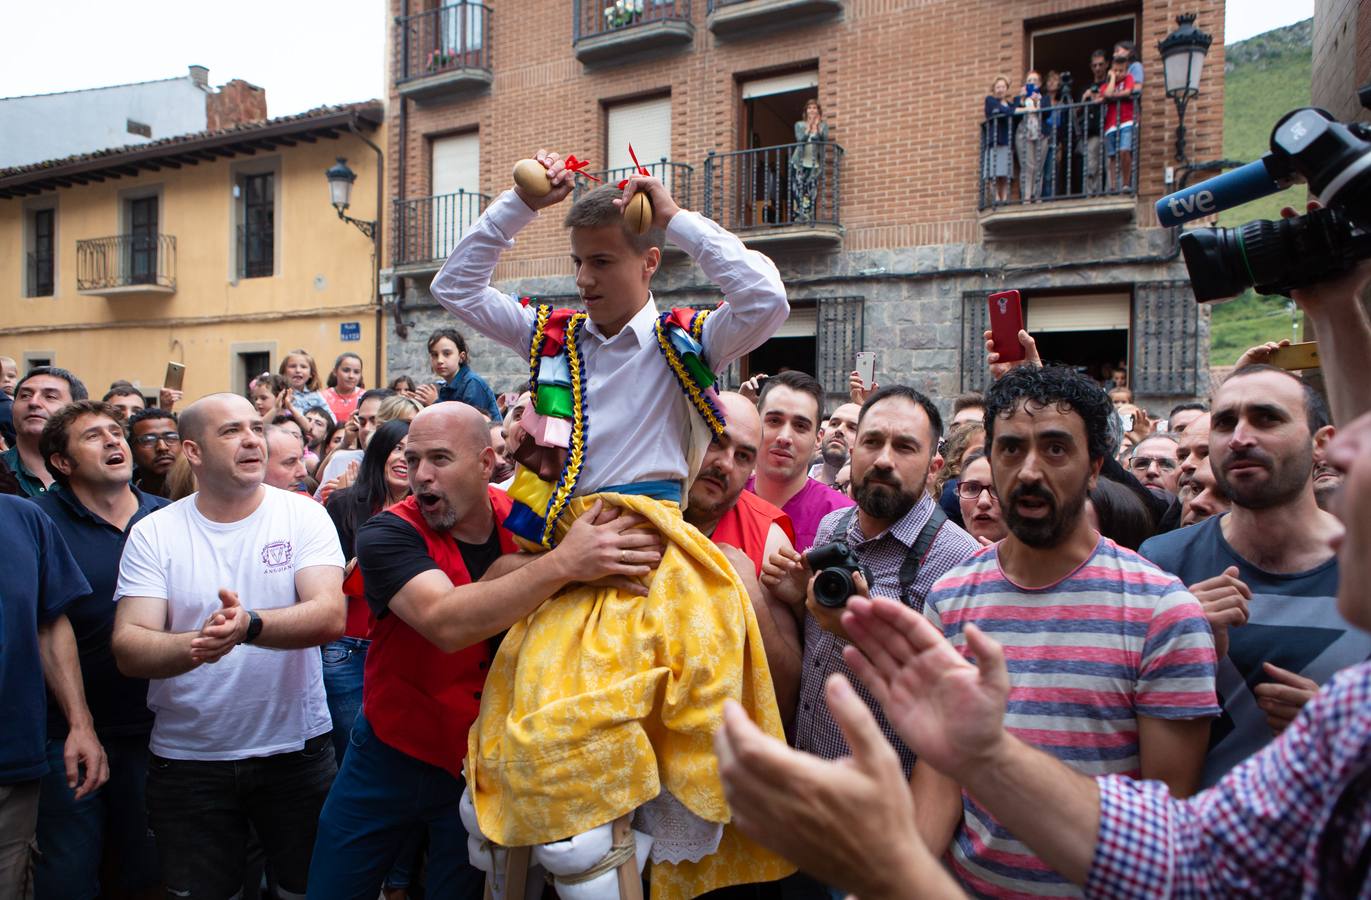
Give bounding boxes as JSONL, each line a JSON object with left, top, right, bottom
{"left": 572, "top": 0, "right": 695, "bottom": 66}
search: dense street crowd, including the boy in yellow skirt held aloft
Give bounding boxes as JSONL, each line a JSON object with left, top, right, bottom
{"left": 0, "top": 155, "right": 1371, "bottom": 900}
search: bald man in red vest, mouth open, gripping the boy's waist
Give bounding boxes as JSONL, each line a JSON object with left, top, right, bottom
{"left": 308, "top": 403, "right": 661, "bottom": 900}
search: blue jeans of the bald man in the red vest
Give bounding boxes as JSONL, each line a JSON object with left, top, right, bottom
{"left": 308, "top": 715, "right": 485, "bottom": 900}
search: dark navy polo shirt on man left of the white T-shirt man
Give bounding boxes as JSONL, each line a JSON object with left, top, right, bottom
{"left": 33, "top": 487, "right": 171, "bottom": 739}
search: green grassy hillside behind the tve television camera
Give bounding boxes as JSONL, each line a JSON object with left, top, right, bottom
{"left": 1209, "top": 19, "right": 1313, "bottom": 366}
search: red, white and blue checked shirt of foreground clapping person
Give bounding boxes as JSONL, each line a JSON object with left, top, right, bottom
{"left": 1086, "top": 663, "right": 1371, "bottom": 900}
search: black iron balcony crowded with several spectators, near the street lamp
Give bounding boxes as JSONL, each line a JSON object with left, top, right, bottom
{"left": 978, "top": 97, "right": 1142, "bottom": 233}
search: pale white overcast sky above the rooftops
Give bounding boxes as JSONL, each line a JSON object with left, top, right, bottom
{"left": 0, "top": 0, "right": 1313, "bottom": 117}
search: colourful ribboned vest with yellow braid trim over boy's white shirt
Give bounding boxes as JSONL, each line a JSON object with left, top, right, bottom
{"left": 505, "top": 306, "right": 724, "bottom": 547}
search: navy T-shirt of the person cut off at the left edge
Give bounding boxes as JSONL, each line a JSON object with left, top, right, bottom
{"left": 0, "top": 495, "right": 90, "bottom": 785}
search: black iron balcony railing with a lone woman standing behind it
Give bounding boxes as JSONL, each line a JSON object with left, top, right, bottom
{"left": 705, "top": 141, "right": 843, "bottom": 237}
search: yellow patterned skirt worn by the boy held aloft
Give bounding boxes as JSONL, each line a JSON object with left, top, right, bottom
{"left": 466, "top": 494, "right": 794, "bottom": 900}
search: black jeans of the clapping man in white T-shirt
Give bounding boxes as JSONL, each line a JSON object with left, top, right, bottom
{"left": 148, "top": 734, "right": 337, "bottom": 900}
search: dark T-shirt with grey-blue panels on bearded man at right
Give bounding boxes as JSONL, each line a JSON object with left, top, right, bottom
{"left": 1139, "top": 516, "right": 1371, "bottom": 788}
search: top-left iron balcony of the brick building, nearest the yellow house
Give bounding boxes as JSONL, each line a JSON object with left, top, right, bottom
{"left": 395, "top": 0, "right": 492, "bottom": 103}
